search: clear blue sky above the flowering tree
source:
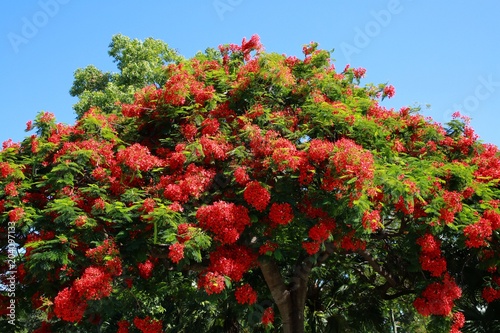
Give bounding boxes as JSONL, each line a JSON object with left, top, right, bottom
{"left": 0, "top": 0, "right": 500, "bottom": 146}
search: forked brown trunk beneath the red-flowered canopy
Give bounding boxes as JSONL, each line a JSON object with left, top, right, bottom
{"left": 259, "top": 259, "right": 311, "bottom": 333}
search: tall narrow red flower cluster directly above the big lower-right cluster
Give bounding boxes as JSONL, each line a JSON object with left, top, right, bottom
{"left": 417, "top": 234, "right": 446, "bottom": 277}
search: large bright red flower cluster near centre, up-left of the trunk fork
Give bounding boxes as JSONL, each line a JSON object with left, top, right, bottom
{"left": 196, "top": 201, "right": 250, "bottom": 244}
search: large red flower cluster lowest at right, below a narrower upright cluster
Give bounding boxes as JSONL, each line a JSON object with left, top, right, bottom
{"left": 413, "top": 274, "right": 462, "bottom": 316}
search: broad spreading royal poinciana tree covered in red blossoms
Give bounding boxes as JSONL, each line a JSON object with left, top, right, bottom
{"left": 0, "top": 36, "right": 500, "bottom": 333}
